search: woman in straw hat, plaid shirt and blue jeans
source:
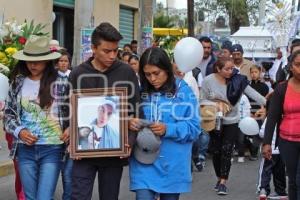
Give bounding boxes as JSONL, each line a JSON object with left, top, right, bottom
{"left": 4, "top": 36, "right": 68, "bottom": 200}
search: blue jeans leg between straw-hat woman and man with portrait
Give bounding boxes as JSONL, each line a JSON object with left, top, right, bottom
{"left": 61, "top": 153, "right": 73, "bottom": 200}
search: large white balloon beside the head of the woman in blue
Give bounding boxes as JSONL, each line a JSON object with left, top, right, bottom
{"left": 174, "top": 37, "right": 203, "bottom": 73}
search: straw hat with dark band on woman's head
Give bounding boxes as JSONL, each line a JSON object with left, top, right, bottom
{"left": 13, "top": 35, "right": 61, "bottom": 61}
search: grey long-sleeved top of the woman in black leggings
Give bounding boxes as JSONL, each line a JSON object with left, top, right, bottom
{"left": 200, "top": 73, "right": 266, "bottom": 124}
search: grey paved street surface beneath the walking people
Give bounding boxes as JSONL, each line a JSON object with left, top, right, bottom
{"left": 0, "top": 156, "right": 259, "bottom": 200}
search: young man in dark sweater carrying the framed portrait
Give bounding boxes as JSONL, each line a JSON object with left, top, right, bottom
{"left": 69, "top": 22, "right": 140, "bottom": 200}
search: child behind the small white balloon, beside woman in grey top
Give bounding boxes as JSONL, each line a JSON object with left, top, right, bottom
{"left": 246, "top": 65, "right": 269, "bottom": 161}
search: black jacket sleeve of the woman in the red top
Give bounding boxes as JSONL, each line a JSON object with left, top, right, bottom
{"left": 263, "top": 81, "right": 288, "bottom": 146}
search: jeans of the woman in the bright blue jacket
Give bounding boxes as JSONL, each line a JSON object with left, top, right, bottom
{"left": 135, "top": 190, "right": 180, "bottom": 200}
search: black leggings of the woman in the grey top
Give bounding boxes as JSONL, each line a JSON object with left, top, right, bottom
{"left": 211, "top": 124, "right": 239, "bottom": 180}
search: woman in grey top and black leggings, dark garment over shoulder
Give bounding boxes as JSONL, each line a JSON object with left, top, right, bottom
{"left": 200, "top": 58, "right": 266, "bottom": 195}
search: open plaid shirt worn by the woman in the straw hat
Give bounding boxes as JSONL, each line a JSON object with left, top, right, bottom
{"left": 3, "top": 75, "right": 69, "bottom": 159}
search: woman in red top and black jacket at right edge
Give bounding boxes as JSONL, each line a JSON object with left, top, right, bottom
{"left": 262, "top": 50, "right": 300, "bottom": 200}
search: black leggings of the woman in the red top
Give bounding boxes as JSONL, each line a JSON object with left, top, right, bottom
{"left": 279, "top": 138, "right": 300, "bottom": 200}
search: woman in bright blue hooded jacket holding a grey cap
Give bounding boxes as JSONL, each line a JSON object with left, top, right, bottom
{"left": 129, "top": 47, "right": 200, "bottom": 200}
